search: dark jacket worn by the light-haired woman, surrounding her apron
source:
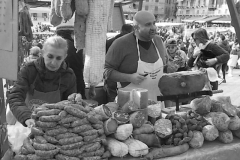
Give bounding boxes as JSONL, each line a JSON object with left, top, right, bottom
{"left": 8, "top": 57, "right": 76, "bottom": 125}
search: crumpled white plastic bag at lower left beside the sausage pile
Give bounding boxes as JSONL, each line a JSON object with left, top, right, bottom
{"left": 7, "top": 122, "right": 31, "bottom": 153}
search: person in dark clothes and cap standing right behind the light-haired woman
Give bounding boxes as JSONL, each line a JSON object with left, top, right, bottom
{"left": 56, "top": 24, "right": 86, "bottom": 99}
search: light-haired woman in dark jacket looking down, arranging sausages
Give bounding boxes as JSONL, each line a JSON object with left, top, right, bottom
{"left": 7, "top": 36, "right": 79, "bottom": 127}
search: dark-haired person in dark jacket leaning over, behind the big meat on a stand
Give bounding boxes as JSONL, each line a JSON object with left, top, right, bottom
{"left": 188, "top": 28, "right": 229, "bottom": 90}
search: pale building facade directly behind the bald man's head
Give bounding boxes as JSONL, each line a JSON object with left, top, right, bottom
{"left": 123, "top": 0, "right": 177, "bottom": 21}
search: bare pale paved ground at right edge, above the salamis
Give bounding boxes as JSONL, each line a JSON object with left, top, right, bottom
{"left": 214, "top": 69, "right": 240, "bottom": 106}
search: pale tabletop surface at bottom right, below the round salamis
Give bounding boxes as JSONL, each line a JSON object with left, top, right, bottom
{"left": 110, "top": 138, "right": 240, "bottom": 160}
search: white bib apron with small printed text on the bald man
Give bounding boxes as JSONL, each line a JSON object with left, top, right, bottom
{"left": 121, "top": 38, "right": 164, "bottom": 102}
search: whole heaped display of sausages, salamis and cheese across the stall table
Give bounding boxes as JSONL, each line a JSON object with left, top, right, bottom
{"left": 11, "top": 74, "right": 240, "bottom": 160}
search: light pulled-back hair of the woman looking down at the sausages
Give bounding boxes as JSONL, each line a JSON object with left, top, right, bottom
{"left": 43, "top": 36, "right": 68, "bottom": 53}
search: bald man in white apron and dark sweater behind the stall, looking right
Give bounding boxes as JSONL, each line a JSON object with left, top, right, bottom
{"left": 104, "top": 11, "right": 167, "bottom": 101}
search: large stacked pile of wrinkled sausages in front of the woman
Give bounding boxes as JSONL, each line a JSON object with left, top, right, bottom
{"left": 15, "top": 101, "right": 108, "bottom": 160}
